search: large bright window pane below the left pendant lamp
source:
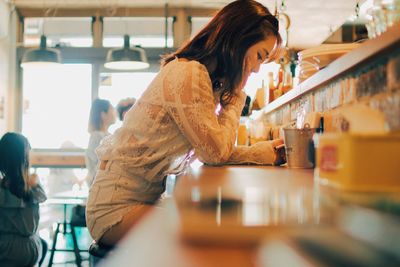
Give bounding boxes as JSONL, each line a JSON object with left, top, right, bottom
{"left": 22, "top": 64, "right": 92, "bottom": 148}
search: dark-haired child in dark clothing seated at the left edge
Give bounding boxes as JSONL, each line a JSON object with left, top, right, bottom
{"left": 0, "top": 133, "right": 47, "bottom": 266}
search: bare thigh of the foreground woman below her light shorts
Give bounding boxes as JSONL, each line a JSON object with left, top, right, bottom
{"left": 99, "top": 204, "right": 153, "bottom": 246}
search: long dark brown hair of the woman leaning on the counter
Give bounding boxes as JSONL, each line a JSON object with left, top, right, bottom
{"left": 163, "top": 0, "right": 282, "bottom": 106}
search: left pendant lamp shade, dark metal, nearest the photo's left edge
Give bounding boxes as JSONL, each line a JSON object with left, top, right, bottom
{"left": 21, "top": 35, "right": 61, "bottom": 68}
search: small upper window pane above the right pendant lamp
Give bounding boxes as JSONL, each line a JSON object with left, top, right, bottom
{"left": 103, "top": 17, "right": 173, "bottom": 47}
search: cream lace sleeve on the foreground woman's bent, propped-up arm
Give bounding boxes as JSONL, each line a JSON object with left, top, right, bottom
{"left": 163, "top": 62, "right": 245, "bottom": 164}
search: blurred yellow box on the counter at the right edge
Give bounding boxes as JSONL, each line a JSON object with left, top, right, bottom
{"left": 314, "top": 133, "right": 400, "bottom": 192}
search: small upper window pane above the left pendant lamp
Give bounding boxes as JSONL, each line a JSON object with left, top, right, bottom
{"left": 24, "top": 17, "right": 93, "bottom": 47}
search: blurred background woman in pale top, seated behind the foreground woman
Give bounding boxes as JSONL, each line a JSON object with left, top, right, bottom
{"left": 85, "top": 99, "right": 116, "bottom": 186}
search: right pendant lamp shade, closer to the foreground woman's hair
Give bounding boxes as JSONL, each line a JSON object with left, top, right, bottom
{"left": 104, "top": 35, "right": 150, "bottom": 70}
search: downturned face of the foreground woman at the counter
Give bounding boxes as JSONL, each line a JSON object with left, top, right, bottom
{"left": 241, "top": 35, "right": 276, "bottom": 89}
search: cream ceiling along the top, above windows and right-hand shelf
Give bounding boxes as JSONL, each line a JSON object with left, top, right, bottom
{"left": 10, "top": 0, "right": 364, "bottom": 49}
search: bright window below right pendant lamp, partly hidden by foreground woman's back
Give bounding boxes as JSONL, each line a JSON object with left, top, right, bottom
{"left": 99, "top": 72, "right": 157, "bottom": 132}
